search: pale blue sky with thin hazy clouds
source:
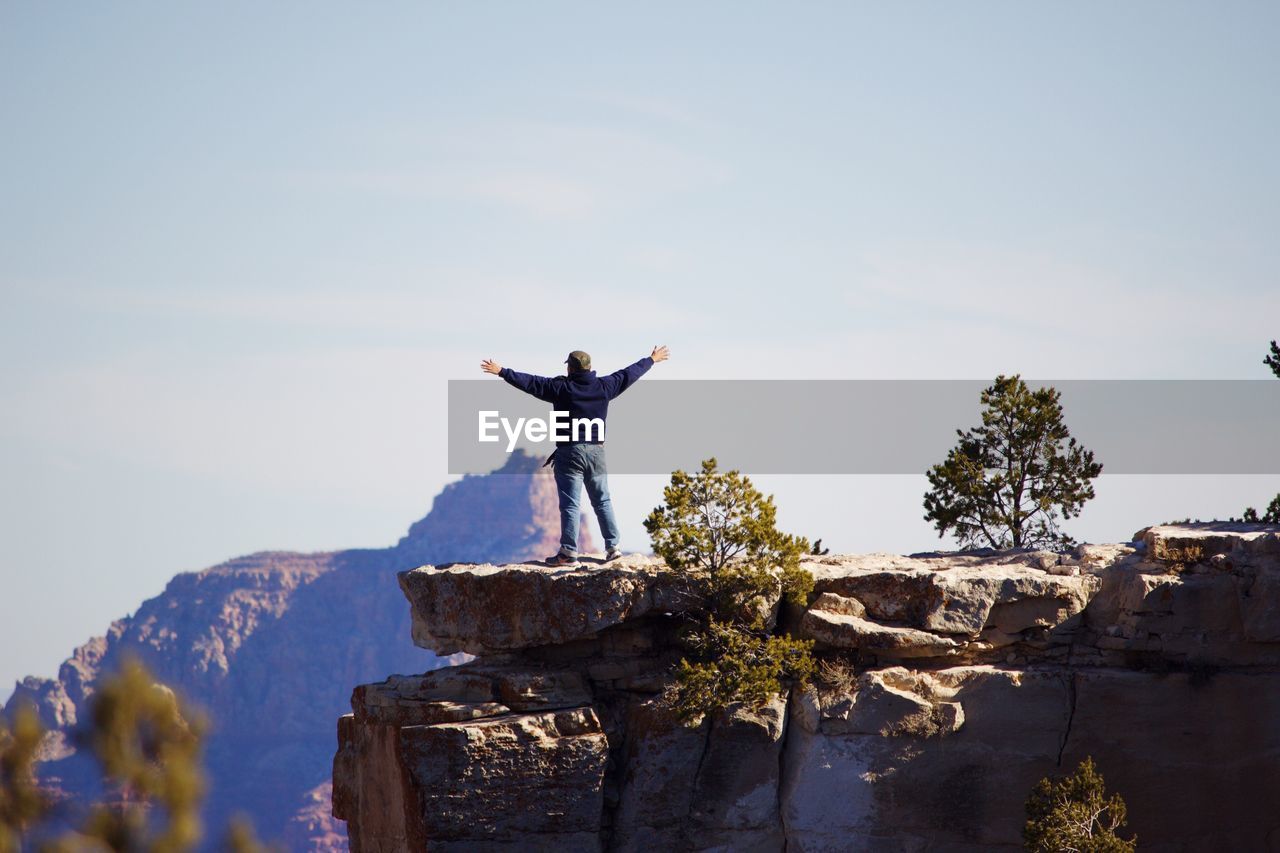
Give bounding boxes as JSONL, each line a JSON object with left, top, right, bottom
{"left": 0, "top": 1, "right": 1280, "bottom": 698}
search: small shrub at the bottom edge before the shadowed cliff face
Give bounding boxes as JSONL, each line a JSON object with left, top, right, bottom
{"left": 1023, "top": 757, "right": 1138, "bottom": 853}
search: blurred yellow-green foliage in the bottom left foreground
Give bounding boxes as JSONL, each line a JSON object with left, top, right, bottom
{"left": 0, "top": 660, "right": 272, "bottom": 853}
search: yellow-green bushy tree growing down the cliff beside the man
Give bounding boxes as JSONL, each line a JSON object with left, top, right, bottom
{"left": 645, "top": 459, "right": 814, "bottom": 721}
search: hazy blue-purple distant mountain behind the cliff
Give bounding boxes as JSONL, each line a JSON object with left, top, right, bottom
{"left": 5, "top": 452, "right": 591, "bottom": 850}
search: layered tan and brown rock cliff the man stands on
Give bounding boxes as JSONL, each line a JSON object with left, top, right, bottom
{"left": 333, "top": 524, "right": 1280, "bottom": 852}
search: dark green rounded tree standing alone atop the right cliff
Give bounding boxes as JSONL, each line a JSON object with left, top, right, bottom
{"left": 924, "top": 375, "right": 1102, "bottom": 549}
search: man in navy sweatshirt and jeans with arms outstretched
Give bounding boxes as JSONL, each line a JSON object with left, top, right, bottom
{"left": 480, "top": 346, "right": 669, "bottom": 566}
